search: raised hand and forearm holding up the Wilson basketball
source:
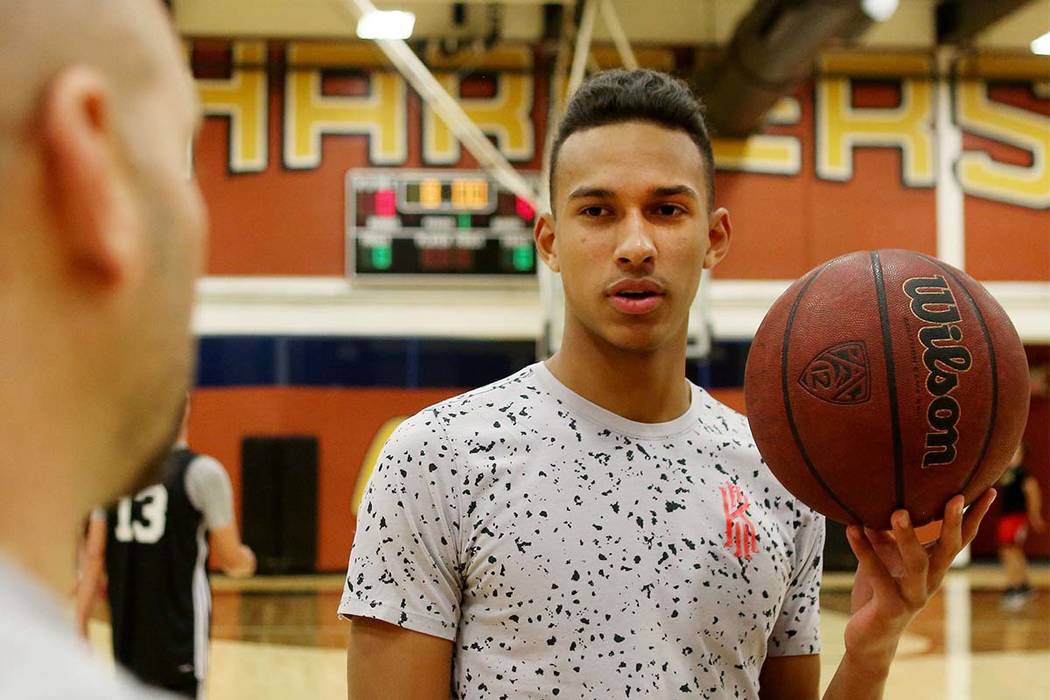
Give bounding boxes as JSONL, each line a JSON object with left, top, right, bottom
{"left": 824, "top": 489, "right": 995, "bottom": 700}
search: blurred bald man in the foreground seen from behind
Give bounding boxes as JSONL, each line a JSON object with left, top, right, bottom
{"left": 0, "top": 0, "right": 207, "bottom": 699}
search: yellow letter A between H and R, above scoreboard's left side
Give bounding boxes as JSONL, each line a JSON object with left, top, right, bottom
{"left": 285, "top": 43, "right": 408, "bottom": 169}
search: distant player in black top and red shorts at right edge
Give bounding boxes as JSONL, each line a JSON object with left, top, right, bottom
{"left": 995, "top": 443, "right": 1047, "bottom": 611}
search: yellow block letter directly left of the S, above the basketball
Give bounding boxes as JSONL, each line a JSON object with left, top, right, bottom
{"left": 816, "top": 55, "right": 936, "bottom": 187}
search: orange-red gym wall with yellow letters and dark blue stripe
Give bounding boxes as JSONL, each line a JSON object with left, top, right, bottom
{"left": 188, "top": 40, "right": 1050, "bottom": 571}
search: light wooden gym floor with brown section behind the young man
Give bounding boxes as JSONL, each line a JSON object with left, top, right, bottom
{"left": 84, "top": 565, "right": 1050, "bottom": 700}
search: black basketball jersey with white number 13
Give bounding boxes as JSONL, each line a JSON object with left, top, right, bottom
{"left": 106, "top": 448, "right": 211, "bottom": 685}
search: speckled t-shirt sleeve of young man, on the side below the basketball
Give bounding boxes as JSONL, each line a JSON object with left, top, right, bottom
{"left": 768, "top": 506, "right": 824, "bottom": 656}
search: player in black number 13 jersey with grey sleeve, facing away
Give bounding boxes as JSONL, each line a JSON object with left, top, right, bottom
{"left": 77, "top": 400, "right": 255, "bottom": 698}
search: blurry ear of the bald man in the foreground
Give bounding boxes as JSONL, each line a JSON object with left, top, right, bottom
{"left": 41, "top": 66, "right": 140, "bottom": 285}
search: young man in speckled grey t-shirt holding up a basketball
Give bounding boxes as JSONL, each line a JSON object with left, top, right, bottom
{"left": 340, "top": 70, "right": 990, "bottom": 700}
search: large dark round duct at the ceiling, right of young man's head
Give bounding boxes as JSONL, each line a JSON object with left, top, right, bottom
{"left": 697, "top": 0, "right": 872, "bottom": 136}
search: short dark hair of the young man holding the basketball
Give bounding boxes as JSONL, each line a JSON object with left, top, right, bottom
{"left": 550, "top": 68, "right": 715, "bottom": 208}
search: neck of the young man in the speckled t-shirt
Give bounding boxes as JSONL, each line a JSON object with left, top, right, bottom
{"left": 546, "top": 325, "right": 691, "bottom": 423}
